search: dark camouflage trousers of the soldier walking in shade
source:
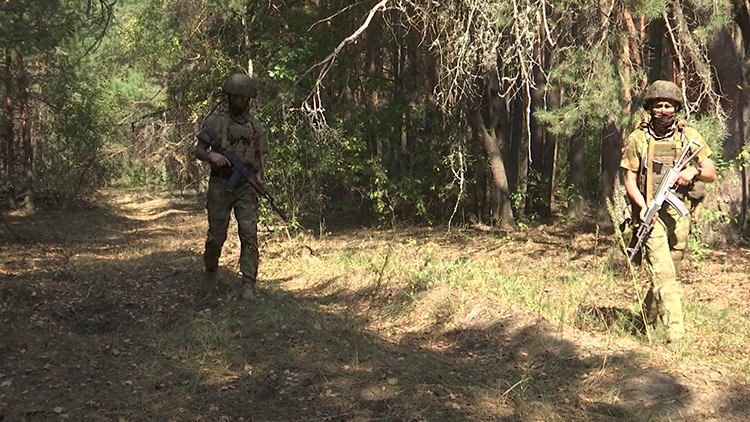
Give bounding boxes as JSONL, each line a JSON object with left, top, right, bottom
{"left": 203, "top": 176, "right": 260, "bottom": 284}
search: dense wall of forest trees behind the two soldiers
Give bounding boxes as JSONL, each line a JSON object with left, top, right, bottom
{"left": 0, "top": 0, "right": 750, "bottom": 241}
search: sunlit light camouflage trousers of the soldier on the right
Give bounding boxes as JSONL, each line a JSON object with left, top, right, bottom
{"left": 644, "top": 207, "right": 691, "bottom": 340}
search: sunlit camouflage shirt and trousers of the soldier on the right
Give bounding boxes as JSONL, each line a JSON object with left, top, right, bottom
{"left": 620, "top": 124, "right": 711, "bottom": 340}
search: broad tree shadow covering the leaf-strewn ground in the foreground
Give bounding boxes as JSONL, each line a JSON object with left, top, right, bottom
{"left": 0, "top": 199, "right": 750, "bottom": 422}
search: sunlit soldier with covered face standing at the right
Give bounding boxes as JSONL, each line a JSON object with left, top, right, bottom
{"left": 620, "top": 81, "right": 716, "bottom": 343}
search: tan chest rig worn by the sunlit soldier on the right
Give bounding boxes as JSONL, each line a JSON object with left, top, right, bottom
{"left": 641, "top": 129, "right": 688, "bottom": 202}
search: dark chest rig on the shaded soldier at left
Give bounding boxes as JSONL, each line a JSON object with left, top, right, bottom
{"left": 219, "top": 113, "right": 261, "bottom": 172}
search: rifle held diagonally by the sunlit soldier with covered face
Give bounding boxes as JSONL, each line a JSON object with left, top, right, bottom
{"left": 625, "top": 139, "right": 703, "bottom": 262}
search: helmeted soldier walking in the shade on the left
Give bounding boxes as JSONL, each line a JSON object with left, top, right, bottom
{"left": 195, "top": 73, "right": 270, "bottom": 300}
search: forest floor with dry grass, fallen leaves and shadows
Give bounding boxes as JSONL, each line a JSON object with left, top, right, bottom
{"left": 0, "top": 192, "right": 750, "bottom": 422}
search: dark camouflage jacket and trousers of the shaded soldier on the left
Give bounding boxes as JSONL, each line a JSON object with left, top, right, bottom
{"left": 196, "top": 73, "right": 270, "bottom": 294}
